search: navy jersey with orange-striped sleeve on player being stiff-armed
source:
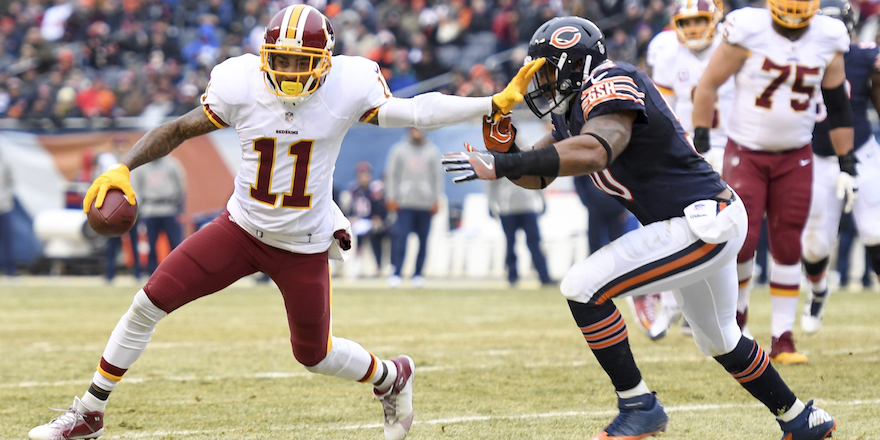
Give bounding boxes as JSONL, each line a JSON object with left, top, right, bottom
{"left": 552, "top": 63, "right": 726, "bottom": 224}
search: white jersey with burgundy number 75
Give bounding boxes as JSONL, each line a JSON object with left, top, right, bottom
{"left": 724, "top": 8, "right": 849, "bottom": 151}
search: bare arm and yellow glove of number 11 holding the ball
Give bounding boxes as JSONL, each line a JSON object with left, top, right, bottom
{"left": 83, "top": 107, "right": 218, "bottom": 213}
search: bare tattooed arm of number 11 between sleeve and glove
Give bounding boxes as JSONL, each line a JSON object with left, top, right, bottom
{"left": 122, "top": 106, "right": 218, "bottom": 170}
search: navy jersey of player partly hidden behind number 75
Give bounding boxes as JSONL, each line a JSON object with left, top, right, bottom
{"left": 813, "top": 43, "right": 880, "bottom": 156}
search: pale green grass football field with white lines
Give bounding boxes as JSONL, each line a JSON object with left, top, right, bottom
{"left": 0, "top": 280, "right": 880, "bottom": 440}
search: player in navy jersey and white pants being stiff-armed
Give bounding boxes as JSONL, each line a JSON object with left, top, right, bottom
{"left": 443, "top": 17, "right": 835, "bottom": 440}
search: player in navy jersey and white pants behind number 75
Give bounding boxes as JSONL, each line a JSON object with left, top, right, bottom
{"left": 801, "top": 0, "right": 880, "bottom": 333}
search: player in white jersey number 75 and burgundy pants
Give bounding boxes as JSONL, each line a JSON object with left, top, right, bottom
{"left": 693, "top": 0, "right": 855, "bottom": 364}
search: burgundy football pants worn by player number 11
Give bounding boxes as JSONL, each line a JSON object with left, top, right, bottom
{"left": 144, "top": 212, "right": 330, "bottom": 366}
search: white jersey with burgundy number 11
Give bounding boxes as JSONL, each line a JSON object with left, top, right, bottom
{"left": 201, "top": 54, "right": 391, "bottom": 254}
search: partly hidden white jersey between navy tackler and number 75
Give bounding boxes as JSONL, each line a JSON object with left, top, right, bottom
{"left": 647, "top": 31, "right": 734, "bottom": 148}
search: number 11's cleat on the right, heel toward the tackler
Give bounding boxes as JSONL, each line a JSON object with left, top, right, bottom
{"left": 373, "top": 355, "right": 416, "bottom": 440}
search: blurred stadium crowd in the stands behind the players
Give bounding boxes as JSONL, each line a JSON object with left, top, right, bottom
{"left": 0, "top": 0, "right": 772, "bottom": 130}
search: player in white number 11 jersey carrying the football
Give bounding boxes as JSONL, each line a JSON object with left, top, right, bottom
{"left": 29, "top": 4, "right": 542, "bottom": 440}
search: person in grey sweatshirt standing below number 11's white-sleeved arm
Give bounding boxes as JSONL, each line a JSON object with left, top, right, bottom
{"left": 385, "top": 128, "right": 444, "bottom": 288}
